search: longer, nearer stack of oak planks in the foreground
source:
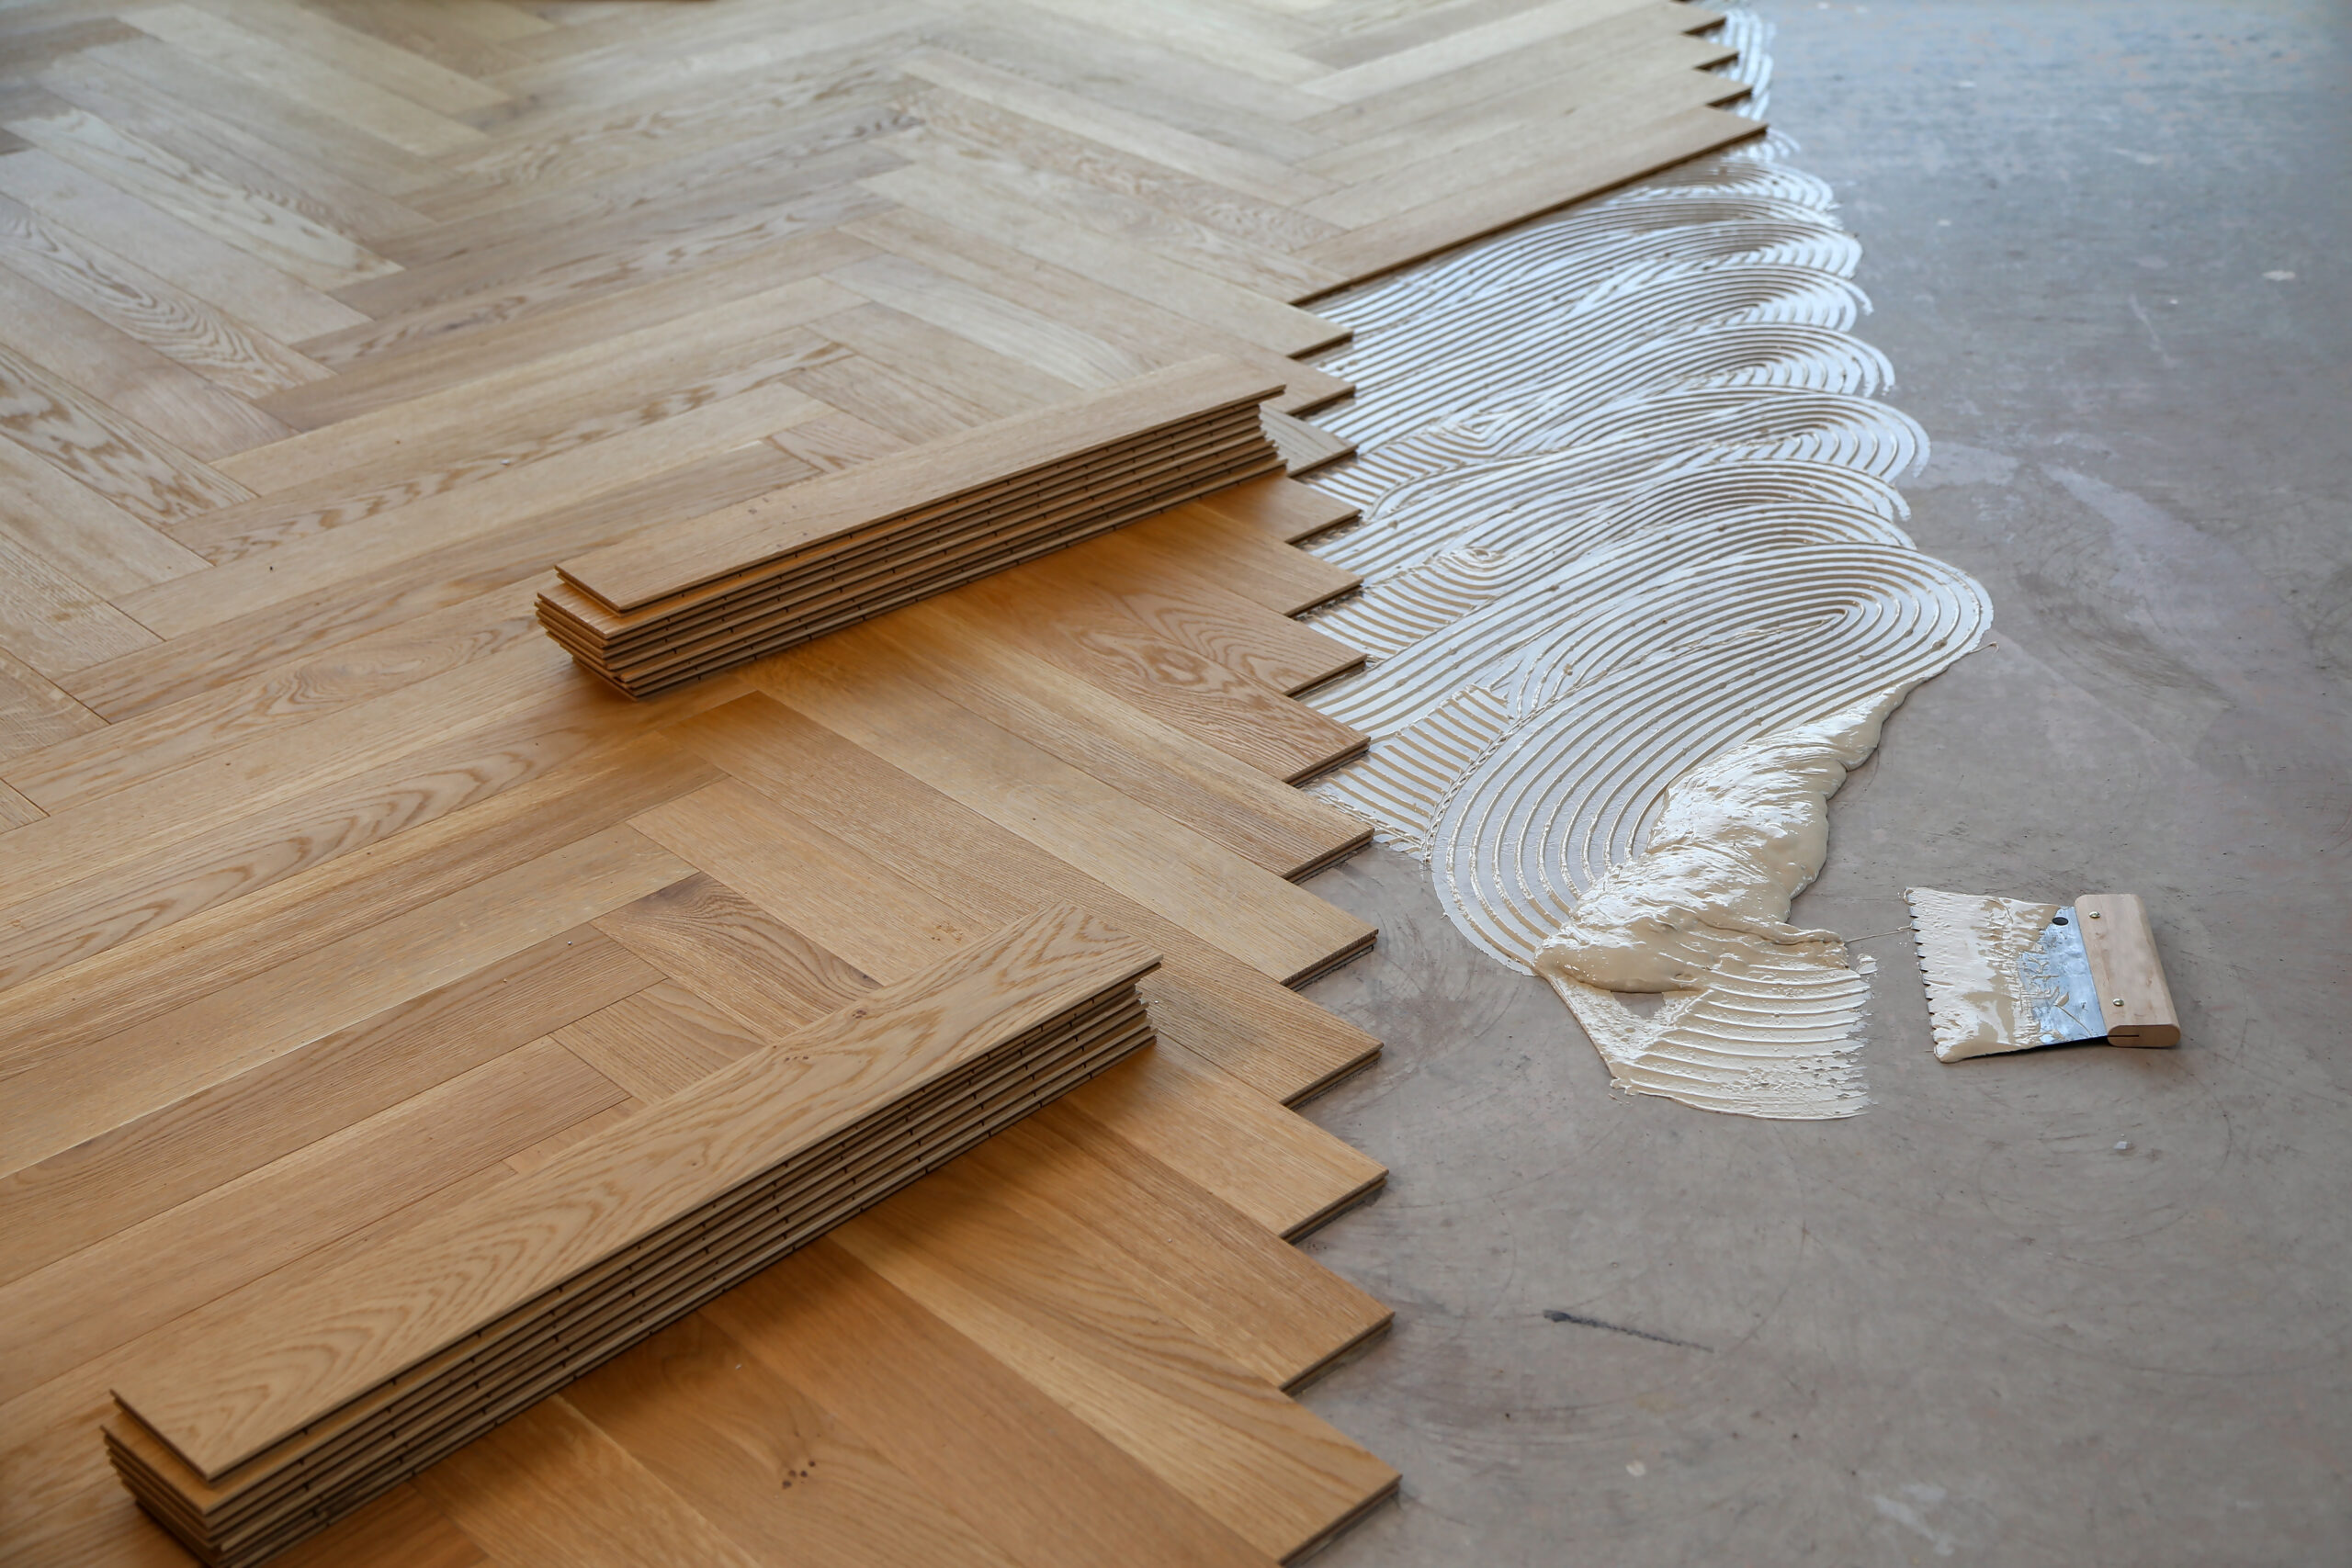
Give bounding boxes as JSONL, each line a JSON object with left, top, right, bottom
{"left": 106, "top": 905, "right": 1159, "bottom": 1563}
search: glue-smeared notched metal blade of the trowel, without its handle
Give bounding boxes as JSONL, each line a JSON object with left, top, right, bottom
{"left": 1905, "top": 888, "right": 2135, "bottom": 1063}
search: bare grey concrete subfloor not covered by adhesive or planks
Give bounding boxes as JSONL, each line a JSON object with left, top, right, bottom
{"left": 1307, "top": 0, "right": 2352, "bottom": 1568}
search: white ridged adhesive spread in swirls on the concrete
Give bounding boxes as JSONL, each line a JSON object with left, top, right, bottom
{"left": 1307, "top": 12, "right": 1992, "bottom": 1119}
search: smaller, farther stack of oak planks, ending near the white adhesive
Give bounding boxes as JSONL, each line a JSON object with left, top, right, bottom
{"left": 538, "top": 355, "right": 1282, "bottom": 698}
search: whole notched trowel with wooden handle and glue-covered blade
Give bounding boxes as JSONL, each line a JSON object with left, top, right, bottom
{"left": 1903, "top": 888, "right": 2180, "bottom": 1063}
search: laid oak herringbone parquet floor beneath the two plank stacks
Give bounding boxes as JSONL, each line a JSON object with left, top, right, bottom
{"left": 0, "top": 0, "right": 1759, "bottom": 1568}
